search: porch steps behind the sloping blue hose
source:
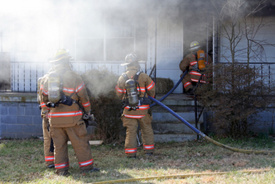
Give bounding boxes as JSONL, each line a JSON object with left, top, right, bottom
{"left": 151, "top": 94, "right": 203, "bottom": 142}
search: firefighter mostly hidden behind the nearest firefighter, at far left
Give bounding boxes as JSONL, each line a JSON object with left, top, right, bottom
{"left": 37, "top": 74, "right": 54, "bottom": 168}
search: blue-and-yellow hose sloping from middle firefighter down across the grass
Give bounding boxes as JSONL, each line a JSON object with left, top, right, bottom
{"left": 149, "top": 96, "right": 275, "bottom": 154}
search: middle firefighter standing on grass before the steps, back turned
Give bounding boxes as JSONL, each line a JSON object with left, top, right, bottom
{"left": 116, "top": 53, "right": 155, "bottom": 158}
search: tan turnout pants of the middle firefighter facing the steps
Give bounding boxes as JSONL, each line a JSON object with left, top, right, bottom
{"left": 122, "top": 114, "right": 154, "bottom": 156}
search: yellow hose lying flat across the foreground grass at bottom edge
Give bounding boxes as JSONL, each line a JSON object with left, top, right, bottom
{"left": 93, "top": 169, "right": 270, "bottom": 184}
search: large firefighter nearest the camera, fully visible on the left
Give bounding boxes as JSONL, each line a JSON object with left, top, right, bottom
{"left": 42, "top": 49, "right": 99, "bottom": 176}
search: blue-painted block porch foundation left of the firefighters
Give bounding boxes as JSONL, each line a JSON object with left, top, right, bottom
{"left": 0, "top": 94, "right": 43, "bottom": 138}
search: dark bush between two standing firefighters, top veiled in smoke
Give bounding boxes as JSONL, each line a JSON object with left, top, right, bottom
{"left": 82, "top": 70, "right": 124, "bottom": 143}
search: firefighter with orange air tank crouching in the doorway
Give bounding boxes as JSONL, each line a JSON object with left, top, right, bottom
{"left": 179, "top": 41, "right": 211, "bottom": 95}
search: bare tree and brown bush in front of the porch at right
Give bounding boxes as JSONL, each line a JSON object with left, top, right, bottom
{"left": 197, "top": 0, "right": 274, "bottom": 137}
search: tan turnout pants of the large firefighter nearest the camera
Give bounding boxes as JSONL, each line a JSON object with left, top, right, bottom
{"left": 51, "top": 123, "right": 93, "bottom": 172}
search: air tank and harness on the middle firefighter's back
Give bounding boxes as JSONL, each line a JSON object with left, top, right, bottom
{"left": 122, "top": 71, "right": 151, "bottom": 111}
